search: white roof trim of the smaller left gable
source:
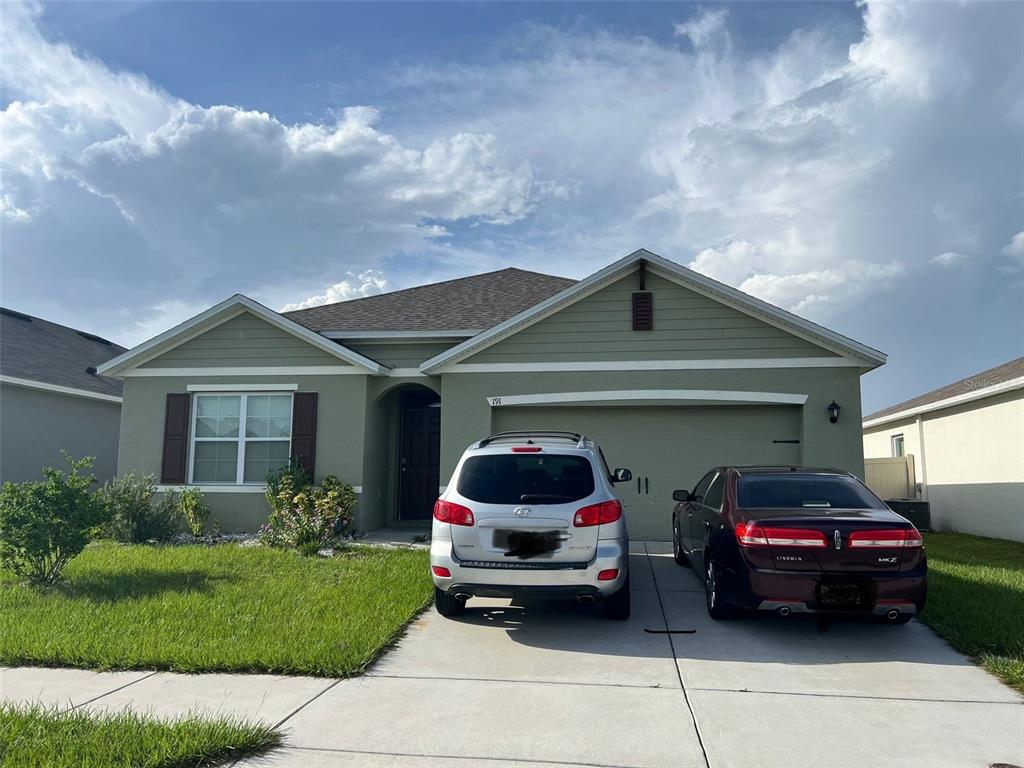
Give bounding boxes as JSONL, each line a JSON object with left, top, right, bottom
{"left": 99, "top": 294, "right": 388, "bottom": 376}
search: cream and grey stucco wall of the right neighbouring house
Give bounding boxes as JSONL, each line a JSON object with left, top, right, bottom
{"left": 863, "top": 390, "right": 1024, "bottom": 541}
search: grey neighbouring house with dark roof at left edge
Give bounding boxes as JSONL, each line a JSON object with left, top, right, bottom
{"left": 0, "top": 308, "right": 125, "bottom": 482}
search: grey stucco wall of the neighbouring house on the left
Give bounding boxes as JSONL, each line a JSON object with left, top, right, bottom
{"left": 0, "top": 384, "right": 121, "bottom": 482}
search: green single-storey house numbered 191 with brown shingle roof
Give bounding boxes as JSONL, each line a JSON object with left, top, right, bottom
{"left": 100, "top": 250, "right": 885, "bottom": 539}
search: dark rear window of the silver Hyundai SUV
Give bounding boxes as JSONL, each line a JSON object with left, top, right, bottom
{"left": 458, "top": 454, "right": 594, "bottom": 504}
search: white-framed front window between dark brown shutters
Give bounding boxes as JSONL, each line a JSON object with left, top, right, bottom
{"left": 190, "top": 394, "right": 292, "bottom": 483}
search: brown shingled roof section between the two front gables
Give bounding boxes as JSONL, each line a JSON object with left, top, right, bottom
{"left": 283, "top": 267, "right": 575, "bottom": 335}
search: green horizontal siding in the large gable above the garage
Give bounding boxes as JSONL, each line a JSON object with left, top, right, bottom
{"left": 463, "top": 273, "right": 835, "bottom": 364}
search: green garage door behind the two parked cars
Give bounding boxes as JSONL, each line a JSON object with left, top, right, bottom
{"left": 493, "top": 406, "right": 801, "bottom": 540}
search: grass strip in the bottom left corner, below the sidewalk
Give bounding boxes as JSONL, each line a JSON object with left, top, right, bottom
{"left": 0, "top": 707, "right": 281, "bottom": 768}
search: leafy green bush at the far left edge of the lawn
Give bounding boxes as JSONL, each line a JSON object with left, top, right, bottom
{"left": 0, "top": 452, "right": 106, "bottom": 584}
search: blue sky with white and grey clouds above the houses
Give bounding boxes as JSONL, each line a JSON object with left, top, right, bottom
{"left": 0, "top": 2, "right": 1024, "bottom": 413}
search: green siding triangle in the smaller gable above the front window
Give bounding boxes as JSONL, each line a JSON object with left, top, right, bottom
{"left": 140, "top": 312, "right": 350, "bottom": 368}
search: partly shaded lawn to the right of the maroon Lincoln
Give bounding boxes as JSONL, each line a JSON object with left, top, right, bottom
{"left": 921, "top": 534, "right": 1024, "bottom": 693}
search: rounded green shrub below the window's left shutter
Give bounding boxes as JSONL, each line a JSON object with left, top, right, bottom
{"left": 100, "top": 472, "right": 181, "bottom": 544}
